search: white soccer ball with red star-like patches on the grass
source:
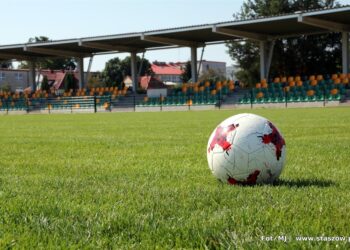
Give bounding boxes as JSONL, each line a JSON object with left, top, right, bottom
{"left": 207, "top": 114, "right": 286, "bottom": 185}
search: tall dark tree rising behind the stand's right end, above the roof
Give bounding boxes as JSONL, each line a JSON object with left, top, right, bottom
{"left": 226, "top": 0, "right": 341, "bottom": 85}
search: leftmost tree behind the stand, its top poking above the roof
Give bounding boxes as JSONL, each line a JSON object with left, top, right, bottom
{"left": 19, "top": 36, "right": 76, "bottom": 70}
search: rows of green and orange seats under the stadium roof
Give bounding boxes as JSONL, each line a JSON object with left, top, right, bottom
{"left": 0, "top": 71, "right": 350, "bottom": 113}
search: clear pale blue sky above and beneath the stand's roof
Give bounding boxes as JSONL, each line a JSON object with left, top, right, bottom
{"left": 0, "top": 0, "right": 350, "bottom": 70}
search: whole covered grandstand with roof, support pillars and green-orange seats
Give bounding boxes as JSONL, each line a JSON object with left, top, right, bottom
{"left": 0, "top": 7, "right": 350, "bottom": 113}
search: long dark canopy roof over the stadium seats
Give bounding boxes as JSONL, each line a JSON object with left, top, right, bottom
{"left": 0, "top": 6, "right": 350, "bottom": 60}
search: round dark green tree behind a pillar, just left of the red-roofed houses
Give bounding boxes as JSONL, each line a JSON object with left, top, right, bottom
{"left": 102, "top": 56, "right": 154, "bottom": 89}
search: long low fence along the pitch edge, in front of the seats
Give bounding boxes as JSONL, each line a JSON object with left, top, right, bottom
{"left": 0, "top": 92, "right": 340, "bottom": 114}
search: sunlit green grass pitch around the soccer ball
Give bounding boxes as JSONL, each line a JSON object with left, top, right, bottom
{"left": 0, "top": 108, "right": 350, "bottom": 249}
